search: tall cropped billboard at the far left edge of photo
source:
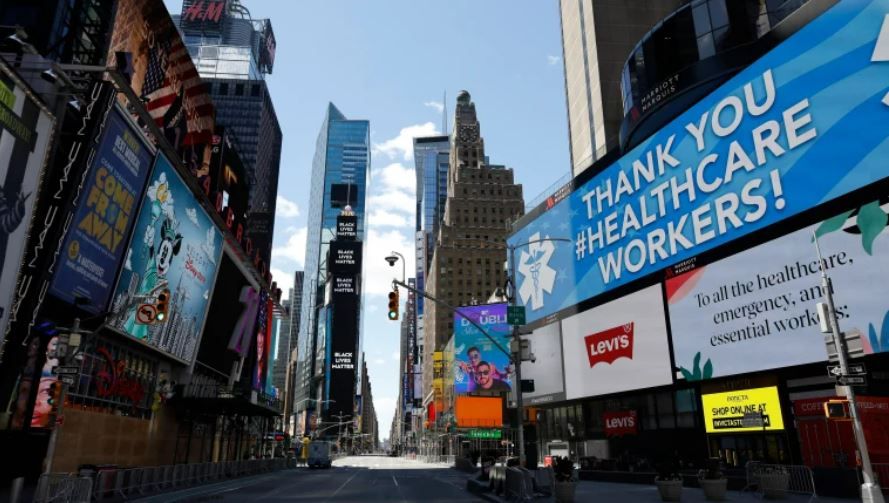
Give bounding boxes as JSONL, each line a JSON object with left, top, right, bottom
{"left": 0, "top": 68, "right": 54, "bottom": 343}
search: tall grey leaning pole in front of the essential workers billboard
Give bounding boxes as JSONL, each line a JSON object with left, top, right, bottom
{"left": 813, "top": 232, "right": 885, "bottom": 503}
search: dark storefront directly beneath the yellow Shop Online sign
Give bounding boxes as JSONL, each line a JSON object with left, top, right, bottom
{"left": 707, "top": 433, "right": 790, "bottom": 468}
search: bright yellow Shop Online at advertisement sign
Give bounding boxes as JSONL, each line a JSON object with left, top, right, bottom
{"left": 701, "top": 386, "right": 784, "bottom": 433}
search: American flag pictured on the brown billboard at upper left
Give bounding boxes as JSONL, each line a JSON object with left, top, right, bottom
{"left": 142, "top": 35, "right": 213, "bottom": 145}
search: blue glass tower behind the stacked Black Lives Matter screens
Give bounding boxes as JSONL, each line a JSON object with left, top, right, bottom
{"left": 295, "top": 103, "right": 370, "bottom": 429}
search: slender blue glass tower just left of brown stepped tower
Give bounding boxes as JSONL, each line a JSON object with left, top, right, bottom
{"left": 405, "top": 135, "right": 451, "bottom": 402}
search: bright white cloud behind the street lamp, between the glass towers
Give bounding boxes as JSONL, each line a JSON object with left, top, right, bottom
{"left": 364, "top": 227, "right": 414, "bottom": 298}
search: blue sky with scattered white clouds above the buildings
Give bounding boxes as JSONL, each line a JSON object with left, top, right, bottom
{"left": 165, "top": 0, "right": 570, "bottom": 438}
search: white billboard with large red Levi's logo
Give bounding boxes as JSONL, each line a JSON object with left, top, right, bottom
{"left": 562, "top": 285, "right": 673, "bottom": 400}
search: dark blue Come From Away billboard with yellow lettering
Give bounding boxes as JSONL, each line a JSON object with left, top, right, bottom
{"left": 50, "top": 111, "right": 154, "bottom": 313}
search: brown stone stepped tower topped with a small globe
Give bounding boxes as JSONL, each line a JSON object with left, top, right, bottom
{"left": 423, "top": 91, "right": 524, "bottom": 395}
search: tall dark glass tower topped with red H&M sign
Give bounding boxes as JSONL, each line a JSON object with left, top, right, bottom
{"left": 173, "top": 0, "right": 282, "bottom": 266}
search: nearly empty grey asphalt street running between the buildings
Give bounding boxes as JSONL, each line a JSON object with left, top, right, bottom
{"left": 138, "top": 456, "right": 482, "bottom": 503}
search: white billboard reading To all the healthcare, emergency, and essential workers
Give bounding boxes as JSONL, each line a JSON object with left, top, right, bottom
{"left": 666, "top": 201, "right": 889, "bottom": 380}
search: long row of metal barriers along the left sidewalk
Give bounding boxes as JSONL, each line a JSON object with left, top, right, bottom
{"left": 35, "top": 458, "right": 287, "bottom": 503}
